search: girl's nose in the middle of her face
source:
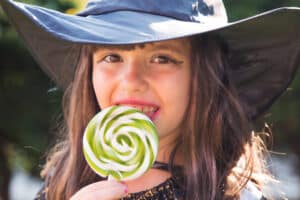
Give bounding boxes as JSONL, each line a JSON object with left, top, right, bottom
{"left": 120, "top": 59, "right": 148, "bottom": 92}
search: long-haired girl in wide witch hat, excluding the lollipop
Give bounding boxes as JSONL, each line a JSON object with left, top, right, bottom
{"left": 1, "top": 0, "right": 300, "bottom": 200}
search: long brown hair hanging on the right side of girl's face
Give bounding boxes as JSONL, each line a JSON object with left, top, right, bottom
{"left": 171, "top": 35, "right": 269, "bottom": 200}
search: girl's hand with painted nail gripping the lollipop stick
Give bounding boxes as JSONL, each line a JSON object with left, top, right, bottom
{"left": 70, "top": 180, "right": 128, "bottom": 200}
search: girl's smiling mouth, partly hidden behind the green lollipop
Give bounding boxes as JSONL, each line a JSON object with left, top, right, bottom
{"left": 113, "top": 99, "right": 159, "bottom": 121}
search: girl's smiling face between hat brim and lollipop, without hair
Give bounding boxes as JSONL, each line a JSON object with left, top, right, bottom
{"left": 92, "top": 39, "right": 191, "bottom": 139}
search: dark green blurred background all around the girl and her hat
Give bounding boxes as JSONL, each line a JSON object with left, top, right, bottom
{"left": 0, "top": 0, "right": 300, "bottom": 200}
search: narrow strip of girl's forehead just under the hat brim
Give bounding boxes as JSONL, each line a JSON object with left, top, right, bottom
{"left": 92, "top": 38, "right": 190, "bottom": 52}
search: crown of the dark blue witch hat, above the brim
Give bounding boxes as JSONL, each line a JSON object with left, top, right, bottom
{"left": 78, "top": 0, "right": 227, "bottom": 23}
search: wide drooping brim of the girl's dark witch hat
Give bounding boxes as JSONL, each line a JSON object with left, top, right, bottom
{"left": 1, "top": 0, "right": 300, "bottom": 118}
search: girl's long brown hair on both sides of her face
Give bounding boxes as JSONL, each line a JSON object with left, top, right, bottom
{"left": 42, "top": 35, "right": 266, "bottom": 200}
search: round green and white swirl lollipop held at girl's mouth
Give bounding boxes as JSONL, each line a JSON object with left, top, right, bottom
{"left": 83, "top": 106, "right": 159, "bottom": 180}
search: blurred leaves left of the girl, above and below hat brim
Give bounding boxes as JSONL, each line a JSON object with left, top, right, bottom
{"left": 0, "top": 0, "right": 85, "bottom": 177}
